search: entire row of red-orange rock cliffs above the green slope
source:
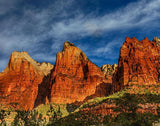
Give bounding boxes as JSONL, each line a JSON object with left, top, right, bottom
{"left": 0, "top": 37, "right": 160, "bottom": 110}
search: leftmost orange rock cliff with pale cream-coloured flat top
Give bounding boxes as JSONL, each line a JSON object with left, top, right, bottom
{"left": 0, "top": 52, "right": 53, "bottom": 110}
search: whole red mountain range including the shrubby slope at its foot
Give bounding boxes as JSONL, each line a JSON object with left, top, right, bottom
{"left": 0, "top": 37, "right": 160, "bottom": 125}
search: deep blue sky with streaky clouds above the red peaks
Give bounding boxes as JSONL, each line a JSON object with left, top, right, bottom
{"left": 0, "top": 0, "right": 160, "bottom": 71}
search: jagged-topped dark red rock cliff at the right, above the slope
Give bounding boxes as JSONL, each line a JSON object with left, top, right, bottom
{"left": 113, "top": 37, "right": 160, "bottom": 91}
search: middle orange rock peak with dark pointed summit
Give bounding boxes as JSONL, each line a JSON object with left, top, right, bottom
{"left": 50, "top": 42, "right": 109, "bottom": 104}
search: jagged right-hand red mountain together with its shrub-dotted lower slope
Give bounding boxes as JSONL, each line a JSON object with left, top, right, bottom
{"left": 74, "top": 37, "right": 160, "bottom": 125}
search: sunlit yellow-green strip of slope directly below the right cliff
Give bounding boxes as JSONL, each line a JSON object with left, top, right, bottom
{"left": 76, "top": 85, "right": 160, "bottom": 111}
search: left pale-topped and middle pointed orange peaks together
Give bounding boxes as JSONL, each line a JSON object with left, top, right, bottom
{"left": 0, "top": 42, "right": 112, "bottom": 110}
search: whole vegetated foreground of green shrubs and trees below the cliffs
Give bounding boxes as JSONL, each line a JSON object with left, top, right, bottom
{"left": 0, "top": 87, "right": 160, "bottom": 126}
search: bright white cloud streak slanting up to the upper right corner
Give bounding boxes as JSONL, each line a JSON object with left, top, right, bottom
{"left": 52, "top": 0, "right": 160, "bottom": 37}
